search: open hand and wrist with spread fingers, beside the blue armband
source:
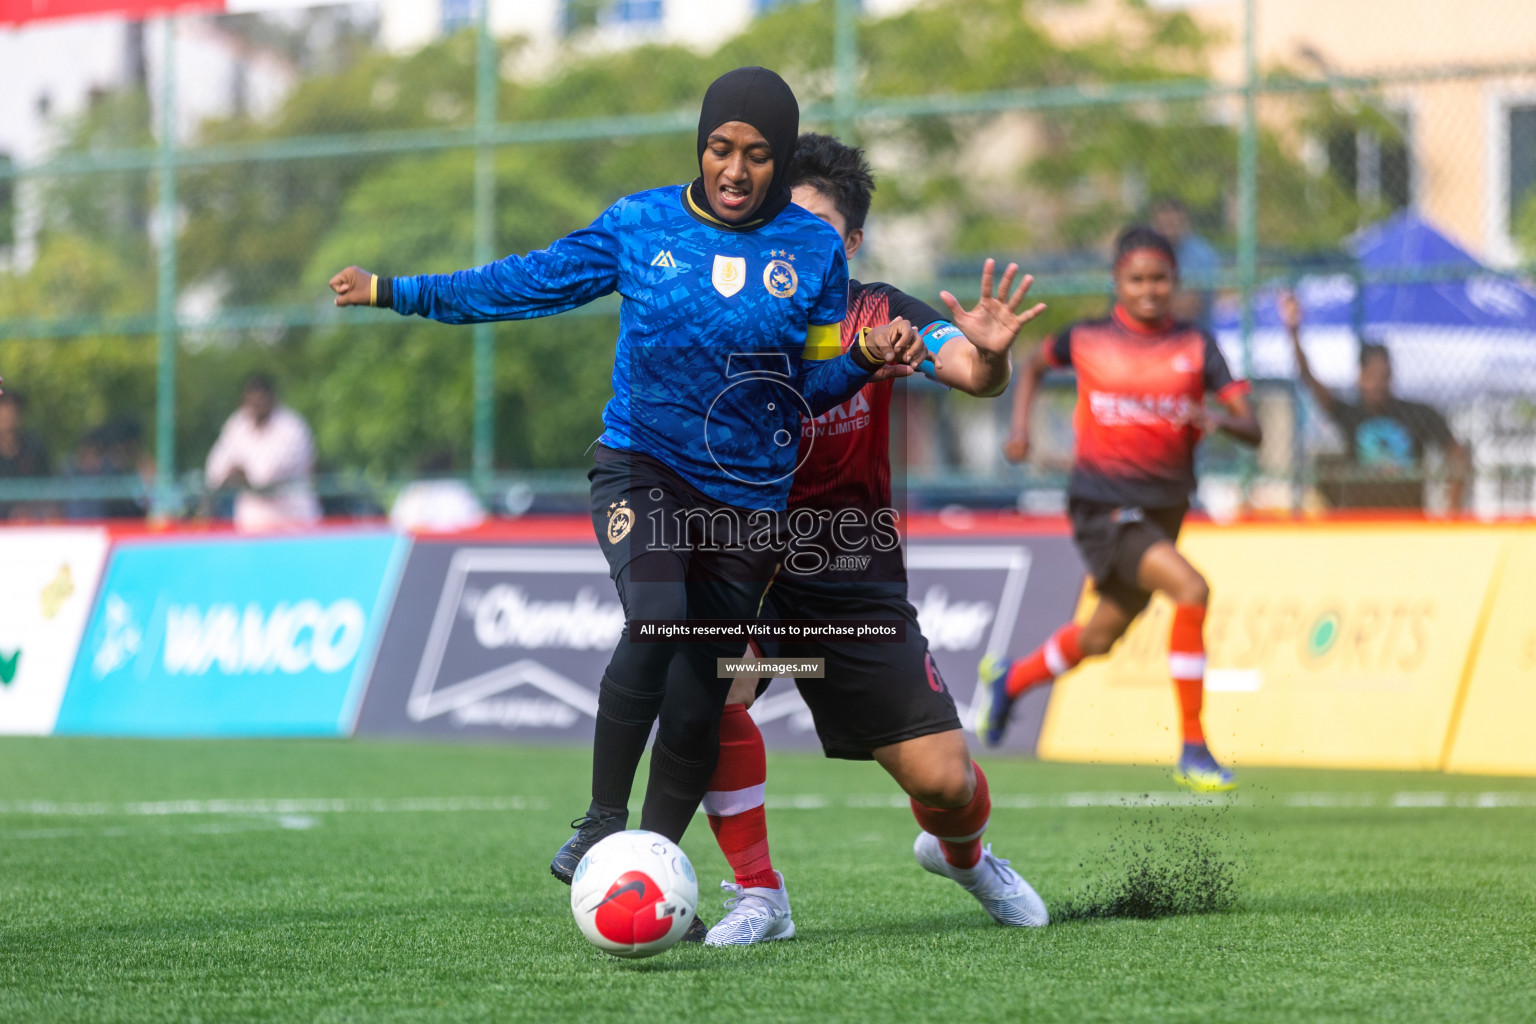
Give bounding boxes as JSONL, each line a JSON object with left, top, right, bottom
{"left": 934, "top": 259, "right": 1046, "bottom": 398}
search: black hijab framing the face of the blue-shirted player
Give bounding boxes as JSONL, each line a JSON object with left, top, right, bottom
{"left": 688, "top": 68, "right": 800, "bottom": 230}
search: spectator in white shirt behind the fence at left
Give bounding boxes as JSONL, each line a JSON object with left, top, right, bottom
{"left": 206, "top": 373, "right": 319, "bottom": 533}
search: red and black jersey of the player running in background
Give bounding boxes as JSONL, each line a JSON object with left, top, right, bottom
{"left": 1044, "top": 306, "right": 1249, "bottom": 508}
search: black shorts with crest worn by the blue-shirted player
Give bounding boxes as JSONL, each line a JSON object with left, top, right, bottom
{"left": 587, "top": 445, "right": 783, "bottom": 592}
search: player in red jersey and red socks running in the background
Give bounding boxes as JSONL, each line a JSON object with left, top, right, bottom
{"left": 977, "top": 226, "right": 1261, "bottom": 792}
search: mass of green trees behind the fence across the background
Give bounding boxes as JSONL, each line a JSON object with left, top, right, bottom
{"left": 0, "top": 0, "right": 1382, "bottom": 488}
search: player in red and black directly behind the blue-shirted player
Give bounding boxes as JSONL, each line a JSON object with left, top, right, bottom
{"left": 703, "top": 134, "right": 1049, "bottom": 946}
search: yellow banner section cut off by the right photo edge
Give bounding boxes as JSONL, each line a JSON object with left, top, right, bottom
{"left": 1444, "top": 527, "right": 1536, "bottom": 775}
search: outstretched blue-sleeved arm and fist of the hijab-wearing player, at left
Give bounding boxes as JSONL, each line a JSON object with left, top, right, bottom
{"left": 330, "top": 207, "right": 619, "bottom": 324}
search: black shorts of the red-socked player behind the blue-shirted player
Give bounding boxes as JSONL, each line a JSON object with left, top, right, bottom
{"left": 759, "top": 574, "right": 960, "bottom": 761}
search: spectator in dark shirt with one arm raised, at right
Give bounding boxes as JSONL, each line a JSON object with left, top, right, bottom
{"left": 1279, "top": 295, "right": 1468, "bottom": 510}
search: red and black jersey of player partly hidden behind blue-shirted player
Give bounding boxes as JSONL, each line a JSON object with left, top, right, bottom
{"left": 790, "top": 281, "right": 960, "bottom": 511}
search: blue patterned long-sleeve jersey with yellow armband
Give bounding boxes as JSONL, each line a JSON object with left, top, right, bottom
{"left": 392, "top": 186, "right": 869, "bottom": 508}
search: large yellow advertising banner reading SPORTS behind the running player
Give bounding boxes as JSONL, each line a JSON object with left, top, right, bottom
{"left": 1040, "top": 524, "right": 1511, "bottom": 769}
